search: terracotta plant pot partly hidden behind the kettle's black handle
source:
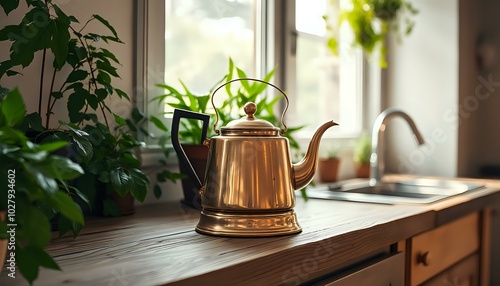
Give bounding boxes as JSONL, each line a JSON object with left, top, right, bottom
{"left": 179, "top": 144, "right": 208, "bottom": 209}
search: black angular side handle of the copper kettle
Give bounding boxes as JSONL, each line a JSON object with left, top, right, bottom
{"left": 171, "top": 109, "right": 210, "bottom": 189}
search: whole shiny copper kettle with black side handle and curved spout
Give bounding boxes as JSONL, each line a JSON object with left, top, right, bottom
{"left": 172, "top": 78, "right": 337, "bottom": 236}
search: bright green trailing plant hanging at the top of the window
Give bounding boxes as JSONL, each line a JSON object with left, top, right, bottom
{"left": 324, "top": 0, "right": 418, "bottom": 68}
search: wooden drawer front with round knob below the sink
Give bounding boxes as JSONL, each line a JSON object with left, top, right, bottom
{"left": 410, "top": 213, "right": 480, "bottom": 285}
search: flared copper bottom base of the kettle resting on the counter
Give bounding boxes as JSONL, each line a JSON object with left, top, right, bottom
{"left": 196, "top": 210, "right": 302, "bottom": 237}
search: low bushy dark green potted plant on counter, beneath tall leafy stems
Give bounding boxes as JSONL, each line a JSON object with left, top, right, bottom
{"left": 70, "top": 115, "right": 150, "bottom": 216}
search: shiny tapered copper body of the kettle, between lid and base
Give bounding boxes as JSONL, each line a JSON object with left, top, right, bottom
{"left": 201, "top": 136, "right": 295, "bottom": 213}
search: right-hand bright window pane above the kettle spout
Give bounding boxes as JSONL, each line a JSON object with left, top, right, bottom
{"left": 287, "top": 0, "right": 363, "bottom": 138}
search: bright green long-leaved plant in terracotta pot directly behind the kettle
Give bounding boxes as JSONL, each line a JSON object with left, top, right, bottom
{"left": 154, "top": 58, "right": 304, "bottom": 208}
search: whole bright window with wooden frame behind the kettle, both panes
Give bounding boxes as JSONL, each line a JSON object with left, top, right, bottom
{"left": 137, "top": 0, "right": 372, "bottom": 147}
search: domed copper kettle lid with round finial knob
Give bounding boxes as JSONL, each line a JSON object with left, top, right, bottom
{"left": 221, "top": 102, "right": 280, "bottom": 136}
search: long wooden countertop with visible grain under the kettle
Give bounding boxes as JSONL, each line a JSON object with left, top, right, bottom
{"left": 0, "top": 178, "right": 500, "bottom": 286}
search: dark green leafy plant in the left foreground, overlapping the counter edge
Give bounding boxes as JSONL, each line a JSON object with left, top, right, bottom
{"left": 0, "top": 89, "right": 84, "bottom": 283}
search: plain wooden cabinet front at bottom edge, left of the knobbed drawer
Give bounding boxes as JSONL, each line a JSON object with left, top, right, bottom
{"left": 321, "top": 252, "right": 405, "bottom": 286}
